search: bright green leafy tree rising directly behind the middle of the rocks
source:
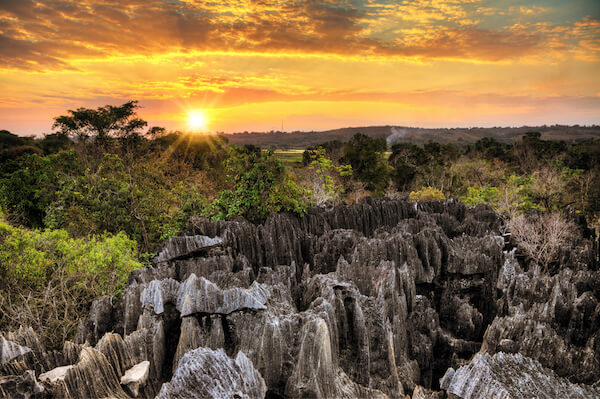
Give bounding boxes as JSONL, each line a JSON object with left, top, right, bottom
{"left": 207, "top": 146, "right": 309, "bottom": 222}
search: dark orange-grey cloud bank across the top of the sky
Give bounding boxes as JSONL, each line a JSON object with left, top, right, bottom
{"left": 0, "top": 0, "right": 598, "bottom": 69}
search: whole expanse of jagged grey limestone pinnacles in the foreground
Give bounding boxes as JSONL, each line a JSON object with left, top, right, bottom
{"left": 0, "top": 198, "right": 600, "bottom": 399}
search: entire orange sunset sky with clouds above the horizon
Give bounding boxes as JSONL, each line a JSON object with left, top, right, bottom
{"left": 0, "top": 0, "right": 600, "bottom": 135}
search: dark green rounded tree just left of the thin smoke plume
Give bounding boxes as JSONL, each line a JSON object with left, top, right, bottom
{"left": 342, "top": 133, "right": 388, "bottom": 193}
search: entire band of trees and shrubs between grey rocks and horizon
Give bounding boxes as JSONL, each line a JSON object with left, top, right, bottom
{"left": 0, "top": 101, "right": 600, "bottom": 345}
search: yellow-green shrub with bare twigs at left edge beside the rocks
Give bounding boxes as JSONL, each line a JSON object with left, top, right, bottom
{"left": 0, "top": 220, "right": 143, "bottom": 348}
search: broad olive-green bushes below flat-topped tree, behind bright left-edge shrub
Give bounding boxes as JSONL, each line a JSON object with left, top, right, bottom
{"left": 44, "top": 154, "right": 200, "bottom": 251}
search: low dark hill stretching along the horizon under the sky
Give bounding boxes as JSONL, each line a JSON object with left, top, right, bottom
{"left": 224, "top": 125, "right": 600, "bottom": 149}
